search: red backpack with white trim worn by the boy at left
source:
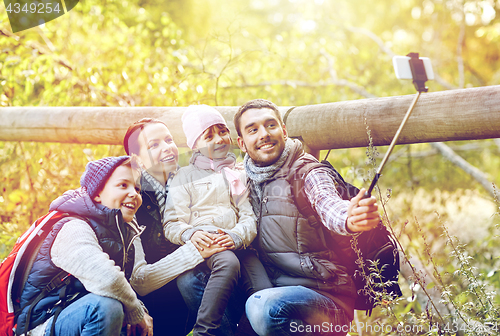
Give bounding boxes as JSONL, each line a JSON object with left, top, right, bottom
{"left": 0, "top": 211, "right": 76, "bottom": 336}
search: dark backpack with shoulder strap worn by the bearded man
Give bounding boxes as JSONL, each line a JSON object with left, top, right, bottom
{"left": 289, "top": 160, "right": 402, "bottom": 315}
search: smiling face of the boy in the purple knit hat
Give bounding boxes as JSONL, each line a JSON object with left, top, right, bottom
{"left": 94, "top": 166, "right": 142, "bottom": 222}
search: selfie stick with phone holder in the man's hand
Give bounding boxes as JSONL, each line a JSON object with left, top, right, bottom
{"left": 363, "top": 53, "right": 427, "bottom": 198}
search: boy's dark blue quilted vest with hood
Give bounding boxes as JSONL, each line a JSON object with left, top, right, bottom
{"left": 16, "top": 189, "right": 134, "bottom": 334}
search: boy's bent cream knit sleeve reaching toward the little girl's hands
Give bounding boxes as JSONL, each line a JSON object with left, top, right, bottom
{"left": 130, "top": 238, "right": 204, "bottom": 296}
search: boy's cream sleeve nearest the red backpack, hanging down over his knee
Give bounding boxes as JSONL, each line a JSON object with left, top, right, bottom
{"left": 50, "top": 219, "right": 144, "bottom": 325}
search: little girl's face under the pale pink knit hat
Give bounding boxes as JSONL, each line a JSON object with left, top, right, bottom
{"left": 195, "top": 124, "right": 231, "bottom": 159}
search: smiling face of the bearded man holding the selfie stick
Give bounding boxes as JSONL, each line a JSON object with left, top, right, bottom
{"left": 238, "top": 108, "right": 287, "bottom": 167}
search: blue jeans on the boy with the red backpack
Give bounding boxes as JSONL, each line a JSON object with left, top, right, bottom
{"left": 45, "top": 293, "right": 124, "bottom": 336}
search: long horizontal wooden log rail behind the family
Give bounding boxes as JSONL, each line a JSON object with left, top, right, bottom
{"left": 0, "top": 85, "right": 500, "bottom": 150}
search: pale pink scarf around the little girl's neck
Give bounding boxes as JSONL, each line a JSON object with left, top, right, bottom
{"left": 189, "top": 151, "right": 246, "bottom": 196}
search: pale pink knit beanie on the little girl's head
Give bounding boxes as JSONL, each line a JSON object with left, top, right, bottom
{"left": 182, "top": 105, "right": 227, "bottom": 149}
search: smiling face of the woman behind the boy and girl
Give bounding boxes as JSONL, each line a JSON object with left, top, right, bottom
{"left": 138, "top": 123, "right": 179, "bottom": 181}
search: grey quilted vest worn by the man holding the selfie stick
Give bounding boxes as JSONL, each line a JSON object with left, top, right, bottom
{"left": 256, "top": 153, "right": 356, "bottom": 297}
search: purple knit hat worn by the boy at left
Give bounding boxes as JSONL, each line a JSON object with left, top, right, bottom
{"left": 80, "top": 155, "right": 130, "bottom": 198}
